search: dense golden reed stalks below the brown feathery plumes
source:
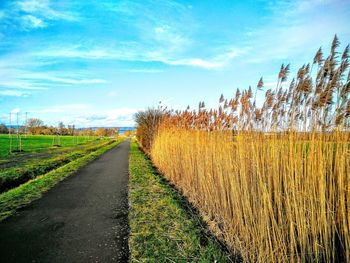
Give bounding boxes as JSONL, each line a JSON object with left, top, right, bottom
{"left": 152, "top": 131, "right": 350, "bottom": 262}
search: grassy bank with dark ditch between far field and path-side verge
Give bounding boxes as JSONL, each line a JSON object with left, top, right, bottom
{"left": 0, "top": 141, "right": 113, "bottom": 193}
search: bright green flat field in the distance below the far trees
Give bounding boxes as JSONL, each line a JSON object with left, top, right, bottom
{"left": 0, "top": 134, "right": 96, "bottom": 158}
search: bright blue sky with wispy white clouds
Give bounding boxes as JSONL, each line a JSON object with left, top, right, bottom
{"left": 0, "top": 0, "right": 350, "bottom": 127}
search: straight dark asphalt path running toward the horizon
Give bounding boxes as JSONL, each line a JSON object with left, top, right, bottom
{"left": 0, "top": 141, "right": 130, "bottom": 263}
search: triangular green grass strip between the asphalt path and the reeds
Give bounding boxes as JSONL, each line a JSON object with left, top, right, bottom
{"left": 129, "top": 142, "right": 232, "bottom": 262}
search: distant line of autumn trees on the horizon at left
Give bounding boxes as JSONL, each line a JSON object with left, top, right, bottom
{"left": 0, "top": 118, "right": 119, "bottom": 137}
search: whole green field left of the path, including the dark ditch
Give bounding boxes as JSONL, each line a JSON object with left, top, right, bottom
{"left": 0, "top": 135, "right": 114, "bottom": 211}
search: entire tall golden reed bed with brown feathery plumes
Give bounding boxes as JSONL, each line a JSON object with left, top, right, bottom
{"left": 138, "top": 36, "right": 350, "bottom": 262}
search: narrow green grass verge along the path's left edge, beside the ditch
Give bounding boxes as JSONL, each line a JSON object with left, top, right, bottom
{"left": 0, "top": 141, "right": 120, "bottom": 221}
